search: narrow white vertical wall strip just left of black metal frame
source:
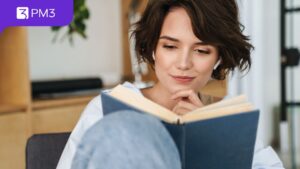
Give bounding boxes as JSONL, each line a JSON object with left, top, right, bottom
{"left": 258, "top": 0, "right": 280, "bottom": 146}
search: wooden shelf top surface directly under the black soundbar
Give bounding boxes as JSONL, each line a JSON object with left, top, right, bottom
{"left": 32, "top": 94, "right": 97, "bottom": 110}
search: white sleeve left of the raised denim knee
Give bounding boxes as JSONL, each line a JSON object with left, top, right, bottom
{"left": 56, "top": 95, "right": 103, "bottom": 169}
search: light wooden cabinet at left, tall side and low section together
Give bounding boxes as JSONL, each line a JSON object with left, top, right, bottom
{"left": 0, "top": 27, "right": 95, "bottom": 169}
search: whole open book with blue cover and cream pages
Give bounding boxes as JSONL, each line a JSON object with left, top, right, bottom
{"left": 101, "top": 85, "right": 259, "bottom": 169}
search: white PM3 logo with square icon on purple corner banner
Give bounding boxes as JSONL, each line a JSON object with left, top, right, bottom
{"left": 16, "top": 7, "right": 55, "bottom": 20}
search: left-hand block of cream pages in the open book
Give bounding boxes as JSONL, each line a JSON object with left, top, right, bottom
{"left": 109, "top": 85, "right": 179, "bottom": 123}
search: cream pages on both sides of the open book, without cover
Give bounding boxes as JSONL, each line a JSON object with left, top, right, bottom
{"left": 109, "top": 85, "right": 253, "bottom": 124}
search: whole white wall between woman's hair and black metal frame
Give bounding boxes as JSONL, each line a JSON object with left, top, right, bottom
{"left": 229, "top": 0, "right": 280, "bottom": 145}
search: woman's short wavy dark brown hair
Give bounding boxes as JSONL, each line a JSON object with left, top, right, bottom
{"left": 132, "top": 0, "right": 253, "bottom": 80}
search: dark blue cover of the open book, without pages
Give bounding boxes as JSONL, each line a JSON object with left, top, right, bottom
{"left": 101, "top": 87, "right": 259, "bottom": 169}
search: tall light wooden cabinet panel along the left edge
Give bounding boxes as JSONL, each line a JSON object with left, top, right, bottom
{"left": 0, "top": 27, "right": 31, "bottom": 169}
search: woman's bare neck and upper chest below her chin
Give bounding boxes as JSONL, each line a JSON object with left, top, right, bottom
{"left": 141, "top": 83, "right": 177, "bottom": 110}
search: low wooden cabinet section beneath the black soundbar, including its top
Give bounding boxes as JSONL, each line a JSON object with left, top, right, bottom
{"left": 31, "top": 96, "right": 94, "bottom": 134}
